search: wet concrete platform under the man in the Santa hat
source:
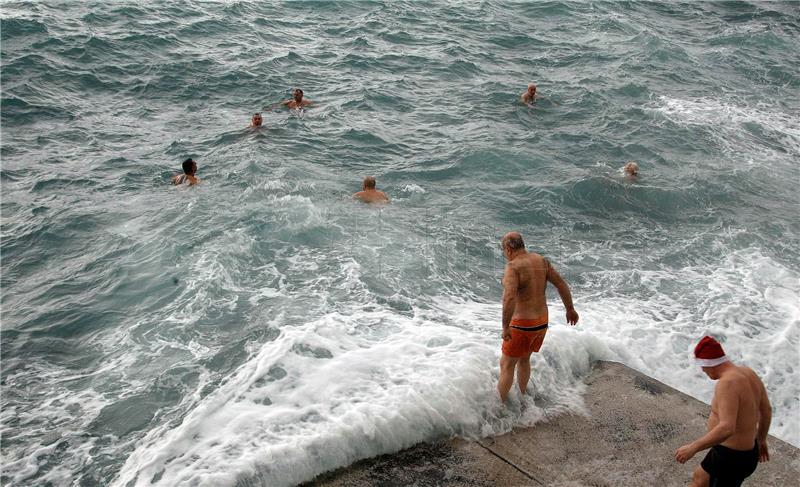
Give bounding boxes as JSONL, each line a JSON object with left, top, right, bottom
{"left": 307, "top": 362, "right": 800, "bottom": 487}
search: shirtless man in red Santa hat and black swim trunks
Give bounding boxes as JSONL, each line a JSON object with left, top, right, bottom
{"left": 675, "top": 336, "right": 772, "bottom": 487}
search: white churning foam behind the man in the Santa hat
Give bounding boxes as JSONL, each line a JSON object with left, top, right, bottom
{"left": 581, "top": 249, "right": 800, "bottom": 444}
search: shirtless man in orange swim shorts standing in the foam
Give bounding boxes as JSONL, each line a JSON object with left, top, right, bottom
{"left": 497, "top": 232, "right": 578, "bottom": 402}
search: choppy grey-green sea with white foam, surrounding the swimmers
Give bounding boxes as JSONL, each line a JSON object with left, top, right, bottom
{"left": 0, "top": 1, "right": 800, "bottom": 486}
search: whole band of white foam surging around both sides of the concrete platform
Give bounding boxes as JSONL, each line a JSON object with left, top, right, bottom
{"left": 108, "top": 236, "right": 800, "bottom": 486}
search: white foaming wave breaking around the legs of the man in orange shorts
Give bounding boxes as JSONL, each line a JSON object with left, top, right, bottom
{"left": 115, "top": 302, "right": 611, "bottom": 485}
